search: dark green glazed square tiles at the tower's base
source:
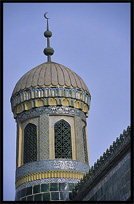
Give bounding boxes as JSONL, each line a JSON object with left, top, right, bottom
{"left": 15, "top": 182, "right": 76, "bottom": 201}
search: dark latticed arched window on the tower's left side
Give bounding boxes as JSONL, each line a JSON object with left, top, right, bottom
{"left": 23, "top": 123, "right": 37, "bottom": 164}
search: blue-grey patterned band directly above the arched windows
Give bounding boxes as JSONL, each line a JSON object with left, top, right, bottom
{"left": 16, "top": 106, "right": 86, "bottom": 122}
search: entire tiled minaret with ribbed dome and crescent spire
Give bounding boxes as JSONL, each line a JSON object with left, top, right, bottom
{"left": 11, "top": 14, "right": 91, "bottom": 201}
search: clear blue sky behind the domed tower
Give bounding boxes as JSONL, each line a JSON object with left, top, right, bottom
{"left": 3, "top": 3, "right": 130, "bottom": 201}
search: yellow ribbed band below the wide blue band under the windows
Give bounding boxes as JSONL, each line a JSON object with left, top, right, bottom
{"left": 15, "top": 171, "right": 84, "bottom": 188}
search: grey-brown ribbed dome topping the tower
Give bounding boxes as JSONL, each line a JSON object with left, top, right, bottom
{"left": 12, "top": 62, "right": 89, "bottom": 96}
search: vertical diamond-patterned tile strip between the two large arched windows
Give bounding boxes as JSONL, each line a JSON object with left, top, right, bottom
{"left": 40, "top": 114, "right": 49, "bottom": 160}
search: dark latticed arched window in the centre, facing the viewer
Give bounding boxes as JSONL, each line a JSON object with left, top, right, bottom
{"left": 54, "top": 120, "right": 72, "bottom": 159}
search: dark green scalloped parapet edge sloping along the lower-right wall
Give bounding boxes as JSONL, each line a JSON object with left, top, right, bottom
{"left": 70, "top": 126, "right": 131, "bottom": 200}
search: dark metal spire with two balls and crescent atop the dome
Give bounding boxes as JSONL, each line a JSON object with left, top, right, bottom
{"left": 44, "top": 12, "right": 54, "bottom": 62}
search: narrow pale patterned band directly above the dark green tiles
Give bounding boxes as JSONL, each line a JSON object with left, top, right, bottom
{"left": 16, "top": 178, "right": 79, "bottom": 193}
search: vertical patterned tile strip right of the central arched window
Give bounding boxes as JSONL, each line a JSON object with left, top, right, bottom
{"left": 75, "top": 117, "right": 85, "bottom": 162}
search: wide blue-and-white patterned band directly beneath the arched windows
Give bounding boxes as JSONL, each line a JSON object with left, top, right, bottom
{"left": 16, "top": 159, "right": 89, "bottom": 180}
